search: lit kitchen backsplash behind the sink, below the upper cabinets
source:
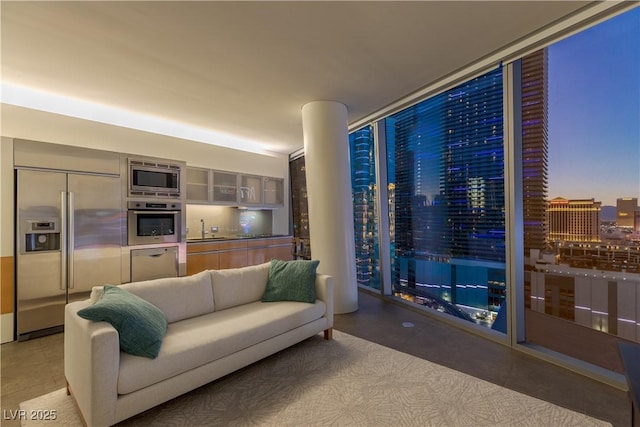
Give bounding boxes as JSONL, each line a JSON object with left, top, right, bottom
{"left": 186, "top": 205, "right": 273, "bottom": 238}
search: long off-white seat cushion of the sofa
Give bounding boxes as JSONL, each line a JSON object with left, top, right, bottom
{"left": 118, "top": 300, "right": 327, "bottom": 394}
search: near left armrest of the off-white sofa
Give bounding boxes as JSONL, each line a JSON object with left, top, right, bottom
{"left": 64, "top": 300, "right": 120, "bottom": 426}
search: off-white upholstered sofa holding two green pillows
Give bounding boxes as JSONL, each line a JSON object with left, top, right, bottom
{"left": 64, "top": 263, "right": 333, "bottom": 426}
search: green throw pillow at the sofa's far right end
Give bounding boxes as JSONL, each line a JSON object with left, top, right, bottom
{"left": 262, "top": 259, "right": 320, "bottom": 304}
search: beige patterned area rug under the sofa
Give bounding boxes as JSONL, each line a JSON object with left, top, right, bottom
{"left": 20, "top": 331, "right": 611, "bottom": 427}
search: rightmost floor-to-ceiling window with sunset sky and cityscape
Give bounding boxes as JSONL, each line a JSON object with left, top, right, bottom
{"left": 521, "top": 9, "right": 640, "bottom": 370}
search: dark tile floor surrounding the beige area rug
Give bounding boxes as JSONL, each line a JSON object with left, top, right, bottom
{"left": 0, "top": 291, "right": 631, "bottom": 427}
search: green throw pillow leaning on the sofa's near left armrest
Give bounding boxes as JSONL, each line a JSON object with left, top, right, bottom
{"left": 78, "top": 285, "right": 167, "bottom": 359}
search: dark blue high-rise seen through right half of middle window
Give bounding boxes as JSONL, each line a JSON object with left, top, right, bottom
{"left": 440, "top": 70, "right": 505, "bottom": 261}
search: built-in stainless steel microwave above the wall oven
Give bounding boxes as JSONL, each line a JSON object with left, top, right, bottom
{"left": 129, "top": 159, "right": 182, "bottom": 198}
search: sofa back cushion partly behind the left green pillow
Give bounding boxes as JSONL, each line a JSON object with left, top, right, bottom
{"left": 117, "top": 271, "right": 213, "bottom": 323}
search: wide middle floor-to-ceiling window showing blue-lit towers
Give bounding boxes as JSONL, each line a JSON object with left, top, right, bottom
{"left": 385, "top": 68, "right": 506, "bottom": 332}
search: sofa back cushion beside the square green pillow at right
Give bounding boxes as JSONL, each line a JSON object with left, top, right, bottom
{"left": 209, "top": 262, "right": 270, "bottom": 311}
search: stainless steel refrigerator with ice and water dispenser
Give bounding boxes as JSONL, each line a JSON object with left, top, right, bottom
{"left": 16, "top": 170, "right": 125, "bottom": 340}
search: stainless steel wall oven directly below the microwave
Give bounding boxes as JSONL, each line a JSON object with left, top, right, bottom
{"left": 127, "top": 202, "right": 182, "bottom": 246}
